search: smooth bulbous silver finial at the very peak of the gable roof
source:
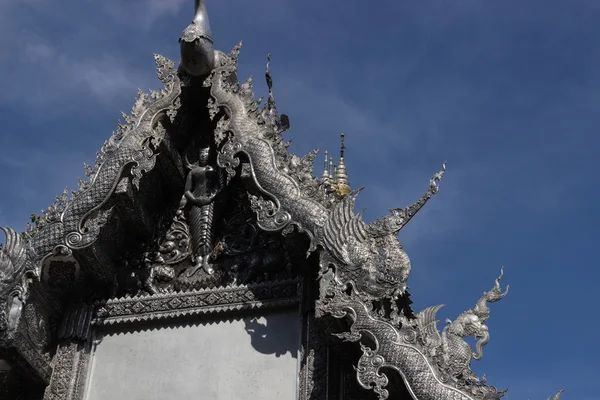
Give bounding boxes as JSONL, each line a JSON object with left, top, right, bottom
{"left": 179, "top": 0, "right": 215, "bottom": 76}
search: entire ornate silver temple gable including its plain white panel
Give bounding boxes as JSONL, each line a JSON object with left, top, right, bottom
{"left": 0, "top": 0, "right": 560, "bottom": 400}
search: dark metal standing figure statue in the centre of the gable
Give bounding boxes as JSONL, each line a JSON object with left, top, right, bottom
{"left": 182, "top": 147, "right": 224, "bottom": 277}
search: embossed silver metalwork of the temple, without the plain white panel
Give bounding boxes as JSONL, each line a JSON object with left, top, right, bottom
{"left": 0, "top": 0, "right": 562, "bottom": 400}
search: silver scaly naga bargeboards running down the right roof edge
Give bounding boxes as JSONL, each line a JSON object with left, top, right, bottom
{"left": 204, "top": 42, "right": 564, "bottom": 400}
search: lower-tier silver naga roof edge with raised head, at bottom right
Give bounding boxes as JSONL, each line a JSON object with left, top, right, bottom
{"left": 320, "top": 272, "right": 507, "bottom": 400}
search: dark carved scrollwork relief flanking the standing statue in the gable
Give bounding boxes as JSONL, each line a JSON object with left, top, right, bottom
{"left": 114, "top": 178, "right": 306, "bottom": 296}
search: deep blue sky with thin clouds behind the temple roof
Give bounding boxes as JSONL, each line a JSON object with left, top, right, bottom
{"left": 0, "top": 0, "right": 600, "bottom": 400}
